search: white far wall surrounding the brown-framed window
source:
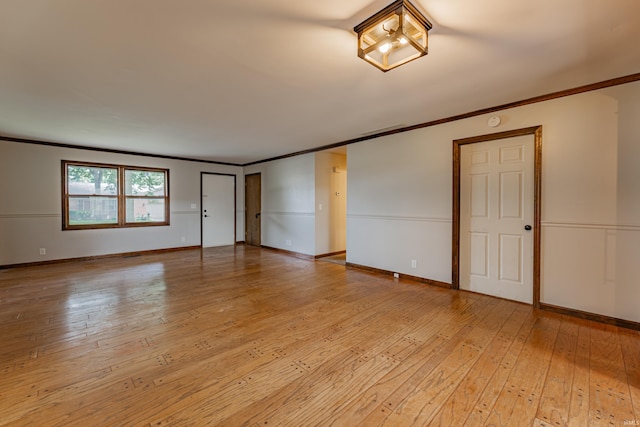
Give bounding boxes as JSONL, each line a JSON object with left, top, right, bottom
{"left": 0, "top": 140, "right": 244, "bottom": 265}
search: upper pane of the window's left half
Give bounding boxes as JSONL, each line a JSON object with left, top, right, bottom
{"left": 67, "top": 165, "right": 118, "bottom": 196}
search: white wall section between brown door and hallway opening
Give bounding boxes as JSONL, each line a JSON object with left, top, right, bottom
{"left": 244, "top": 153, "right": 315, "bottom": 255}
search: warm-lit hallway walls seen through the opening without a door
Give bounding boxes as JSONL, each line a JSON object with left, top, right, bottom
{"left": 315, "top": 151, "right": 347, "bottom": 255}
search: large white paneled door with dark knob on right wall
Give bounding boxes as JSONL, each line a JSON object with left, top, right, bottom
{"left": 460, "top": 135, "right": 535, "bottom": 304}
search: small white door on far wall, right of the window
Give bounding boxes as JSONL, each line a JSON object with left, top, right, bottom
{"left": 202, "top": 174, "right": 236, "bottom": 248}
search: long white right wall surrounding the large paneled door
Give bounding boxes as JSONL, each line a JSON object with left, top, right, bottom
{"left": 347, "top": 82, "right": 640, "bottom": 322}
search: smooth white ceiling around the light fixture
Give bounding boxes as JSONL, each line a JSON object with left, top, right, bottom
{"left": 0, "top": 0, "right": 640, "bottom": 164}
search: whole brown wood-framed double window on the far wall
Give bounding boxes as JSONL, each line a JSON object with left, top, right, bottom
{"left": 62, "top": 160, "right": 169, "bottom": 230}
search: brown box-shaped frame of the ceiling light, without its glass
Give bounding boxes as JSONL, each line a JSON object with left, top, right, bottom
{"left": 353, "top": 0, "right": 433, "bottom": 72}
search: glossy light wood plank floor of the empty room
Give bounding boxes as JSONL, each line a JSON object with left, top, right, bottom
{"left": 0, "top": 246, "right": 640, "bottom": 427}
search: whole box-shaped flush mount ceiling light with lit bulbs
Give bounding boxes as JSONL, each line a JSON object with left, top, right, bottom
{"left": 353, "top": 0, "right": 432, "bottom": 71}
